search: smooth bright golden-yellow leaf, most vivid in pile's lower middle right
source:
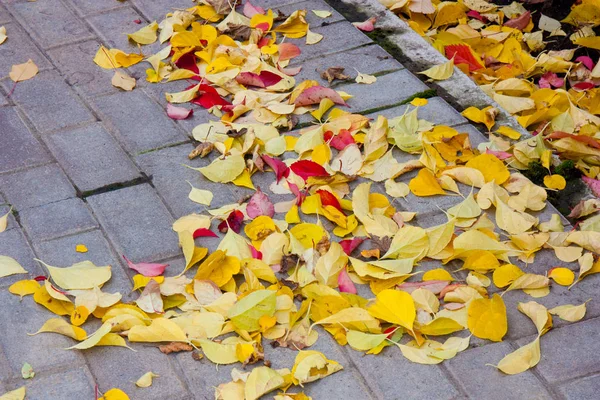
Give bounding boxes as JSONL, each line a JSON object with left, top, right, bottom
{"left": 368, "top": 289, "right": 416, "bottom": 330}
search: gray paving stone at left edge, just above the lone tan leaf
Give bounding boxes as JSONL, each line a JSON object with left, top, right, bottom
{"left": 0, "top": 22, "right": 52, "bottom": 78}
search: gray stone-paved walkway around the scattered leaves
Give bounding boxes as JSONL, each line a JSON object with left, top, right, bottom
{"left": 0, "top": 0, "right": 600, "bottom": 400}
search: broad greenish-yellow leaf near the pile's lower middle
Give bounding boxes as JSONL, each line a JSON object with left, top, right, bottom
{"left": 227, "top": 290, "right": 277, "bottom": 332}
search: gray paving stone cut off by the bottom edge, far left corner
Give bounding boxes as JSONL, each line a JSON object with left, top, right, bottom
{"left": 12, "top": 368, "right": 95, "bottom": 400}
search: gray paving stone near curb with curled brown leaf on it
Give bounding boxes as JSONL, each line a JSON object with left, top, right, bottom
{"left": 294, "top": 45, "right": 403, "bottom": 87}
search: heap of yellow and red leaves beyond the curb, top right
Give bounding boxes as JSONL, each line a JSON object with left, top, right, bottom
{"left": 379, "top": 0, "right": 600, "bottom": 202}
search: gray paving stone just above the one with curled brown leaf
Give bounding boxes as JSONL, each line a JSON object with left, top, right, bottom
{"left": 290, "top": 21, "right": 371, "bottom": 65}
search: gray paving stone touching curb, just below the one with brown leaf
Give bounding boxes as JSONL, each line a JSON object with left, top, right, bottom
{"left": 340, "top": 69, "right": 429, "bottom": 113}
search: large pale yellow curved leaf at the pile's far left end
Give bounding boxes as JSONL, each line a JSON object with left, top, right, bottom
{"left": 38, "top": 260, "right": 111, "bottom": 290}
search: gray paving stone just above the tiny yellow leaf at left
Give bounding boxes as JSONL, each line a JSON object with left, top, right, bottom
{"left": 20, "top": 198, "right": 98, "bottom": 241}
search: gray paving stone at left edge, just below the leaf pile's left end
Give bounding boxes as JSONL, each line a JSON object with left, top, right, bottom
{"left": 0, "top": 290, "right": 84, "bottom": 376}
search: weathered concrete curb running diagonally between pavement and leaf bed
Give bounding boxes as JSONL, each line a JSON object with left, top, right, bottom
{"left": 328, "top": 0, "right": 531, "bottom": 138}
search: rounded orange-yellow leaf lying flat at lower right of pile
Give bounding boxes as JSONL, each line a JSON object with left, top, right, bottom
{"left": 467, "top": 293, "right": 508, "bottom": 342}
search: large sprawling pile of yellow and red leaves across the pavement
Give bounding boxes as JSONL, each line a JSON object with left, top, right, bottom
{"left": 0, "top": 1, "right": 600, "bottom": 400}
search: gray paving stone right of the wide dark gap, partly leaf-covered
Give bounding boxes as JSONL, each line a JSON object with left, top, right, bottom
{"left": 136, "top": 144, "right": 253, "bottom": 217}
